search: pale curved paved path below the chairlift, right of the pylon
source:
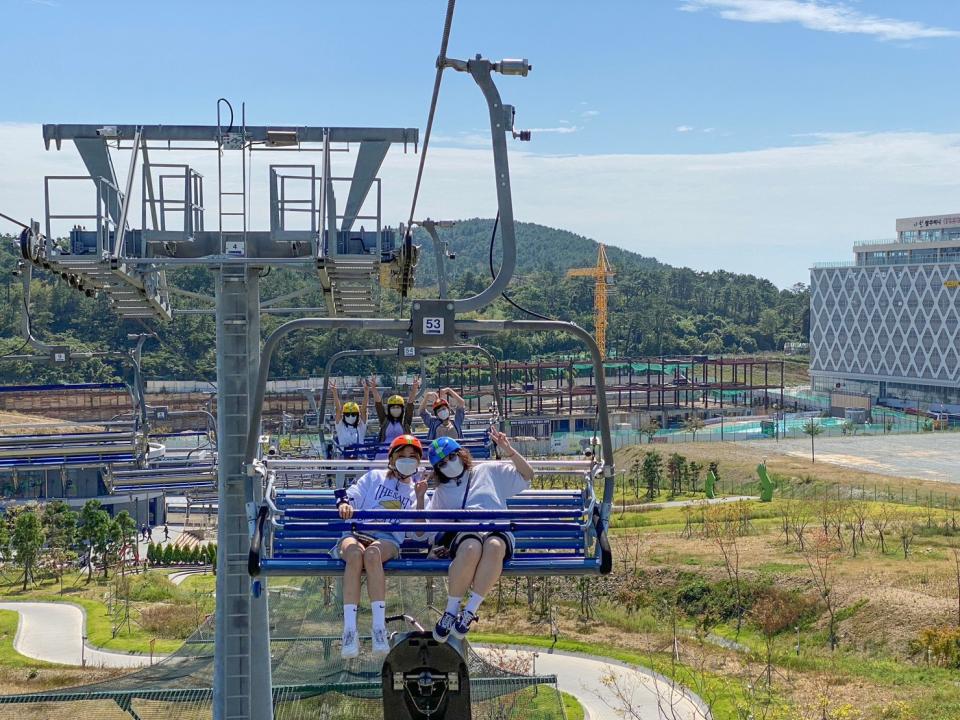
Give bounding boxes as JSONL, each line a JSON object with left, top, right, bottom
{"left": 476, "top": 647, "right": 710, "bottom": 720}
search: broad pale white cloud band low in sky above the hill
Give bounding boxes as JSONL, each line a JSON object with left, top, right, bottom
{"left": 0, "top": 124, "right": 960, "bottom": 287}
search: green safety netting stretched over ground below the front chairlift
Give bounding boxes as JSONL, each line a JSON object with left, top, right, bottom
{"left": 0, "top": 577, "right": 564, "bottom": 720}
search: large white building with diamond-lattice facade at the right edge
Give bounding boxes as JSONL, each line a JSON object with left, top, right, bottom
{"left": 810, "top": 214, "right": 960, "bottom": 403}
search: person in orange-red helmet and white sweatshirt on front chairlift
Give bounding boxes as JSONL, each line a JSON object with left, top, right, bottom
{"left": 334, "top": 435, "right": 427, "bottom": 658}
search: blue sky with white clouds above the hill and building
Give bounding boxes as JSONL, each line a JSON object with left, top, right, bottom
{"left": 0, "top": 0, "right": 960, "bottom": 287}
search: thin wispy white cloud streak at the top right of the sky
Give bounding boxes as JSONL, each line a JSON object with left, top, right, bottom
{"left": 680, "top": 0, "right": 960, "bottom": 40}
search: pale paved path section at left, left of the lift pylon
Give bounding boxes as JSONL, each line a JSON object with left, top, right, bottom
{"left": 0, "top": 602, "right": 150, "bottom": 668}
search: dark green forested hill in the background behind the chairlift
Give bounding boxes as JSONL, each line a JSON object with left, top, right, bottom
{"left": 0, "top": 224, "right": 809, "bottom": 383}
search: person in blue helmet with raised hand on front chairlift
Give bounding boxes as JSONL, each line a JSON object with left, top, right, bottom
{"left": 427, "top": 428, "right": 533, "bottom": 642}
